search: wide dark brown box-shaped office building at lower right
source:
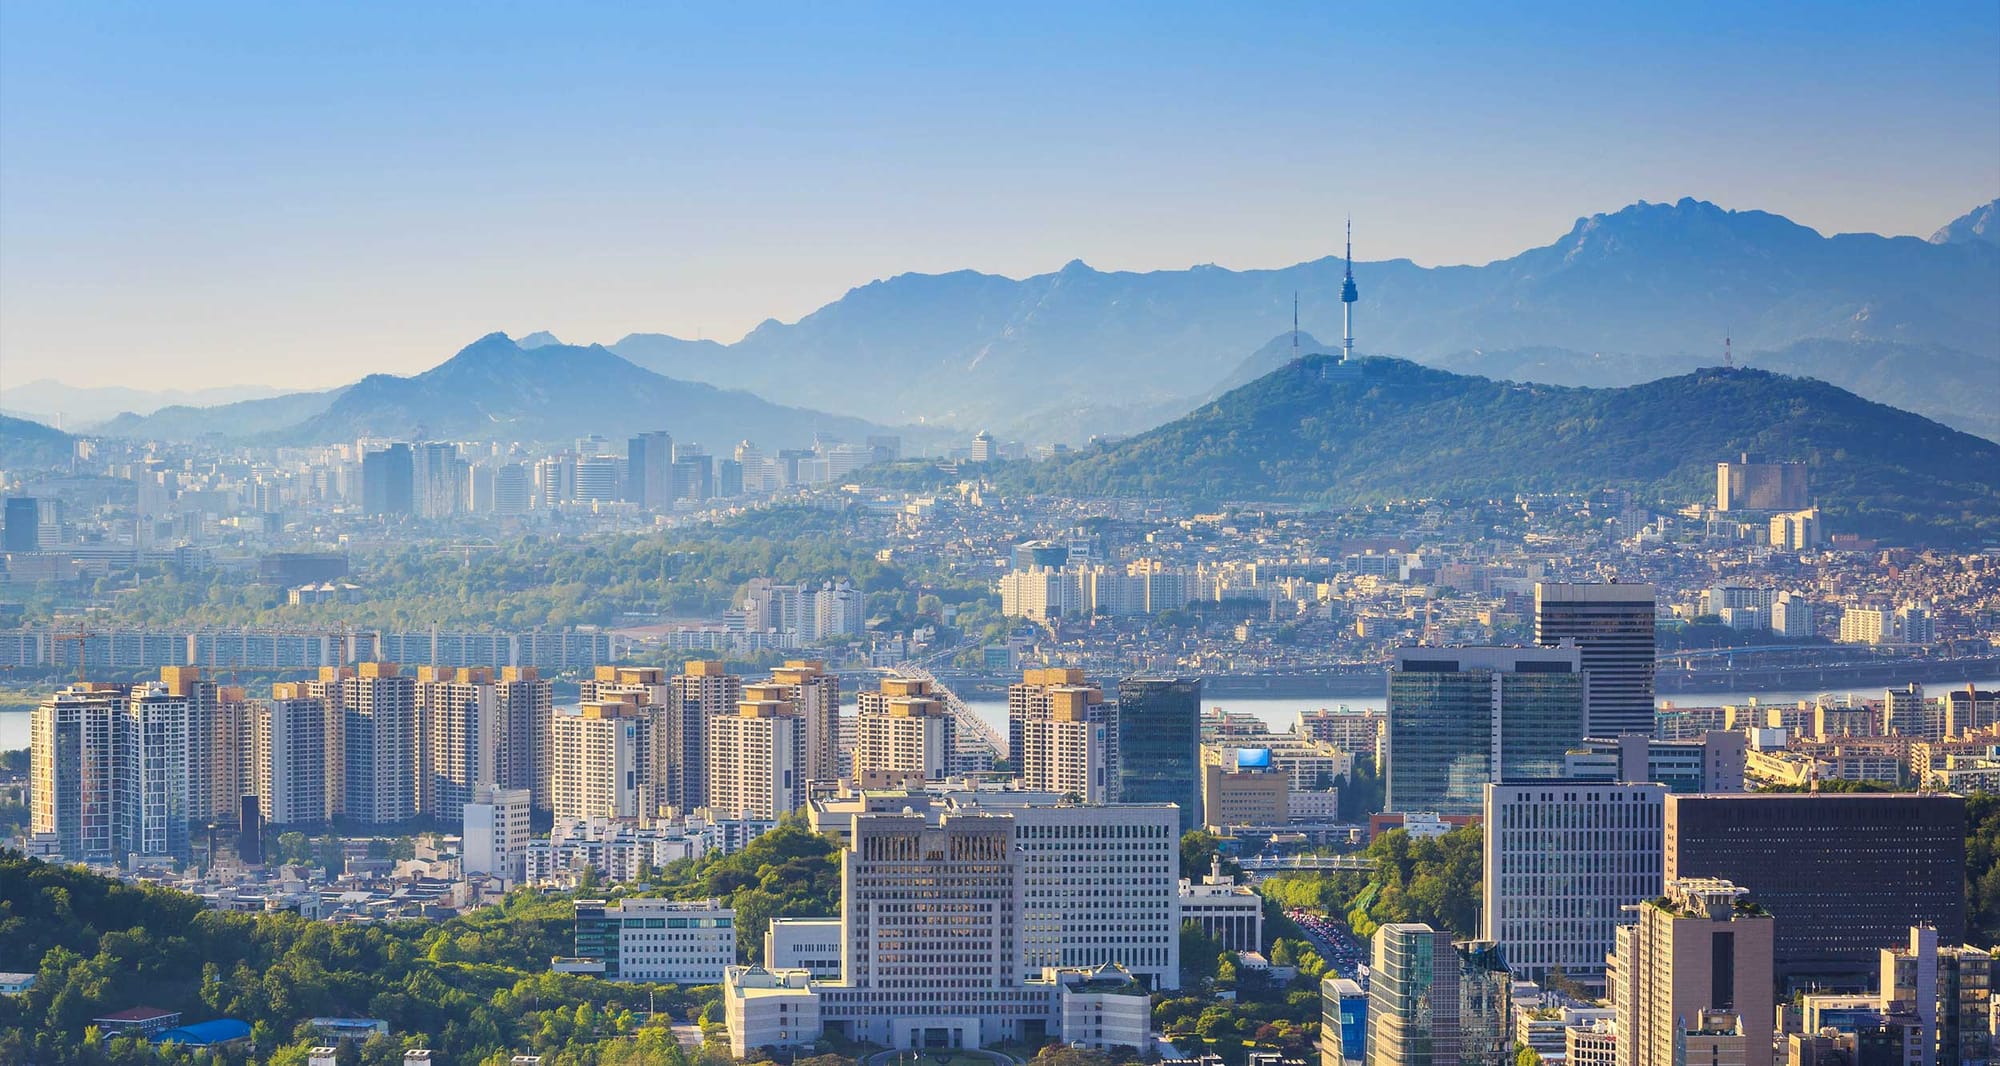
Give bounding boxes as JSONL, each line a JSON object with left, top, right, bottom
{"left": 1664, "top": 792, "right": 1966, "bottom": 982}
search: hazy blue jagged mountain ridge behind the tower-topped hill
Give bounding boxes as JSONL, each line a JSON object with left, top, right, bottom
{"left": 612, "top": 198, "right": 2000, "bottom": 442}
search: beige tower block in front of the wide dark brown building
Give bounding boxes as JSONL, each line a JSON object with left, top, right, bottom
{"left": 1608, "top": 878, "right": 1776, "bottom": 1066}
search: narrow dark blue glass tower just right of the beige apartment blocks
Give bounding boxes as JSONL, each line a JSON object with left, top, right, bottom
{"left": 1116, "top": 678, "right": 1202, "bottom": 832}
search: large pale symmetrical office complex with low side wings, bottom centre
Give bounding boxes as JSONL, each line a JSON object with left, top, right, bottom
{"left": 724, "top": 782, "right": 1262, "bottom": 1056}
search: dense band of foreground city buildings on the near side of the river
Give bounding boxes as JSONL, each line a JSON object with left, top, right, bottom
{"left": 15, "top": 564, "right": 2000, "bottom": 1066}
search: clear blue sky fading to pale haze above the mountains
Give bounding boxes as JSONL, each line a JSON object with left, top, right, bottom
{"left": 0, "top": 0, "right": 2000, "bottom": 386}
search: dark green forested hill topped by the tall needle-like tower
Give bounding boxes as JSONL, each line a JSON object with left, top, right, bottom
{"left": 1014, "top": 356, "right": 2000, "bottom": 546}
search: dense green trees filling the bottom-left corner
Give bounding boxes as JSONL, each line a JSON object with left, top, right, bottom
{"left": 0, "top": 852, "right": 720, "bottom": 1066}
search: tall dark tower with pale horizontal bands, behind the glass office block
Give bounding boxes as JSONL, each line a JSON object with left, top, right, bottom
{"left": 1534, "top": 582, "right": 1654, "bottom": 736}
